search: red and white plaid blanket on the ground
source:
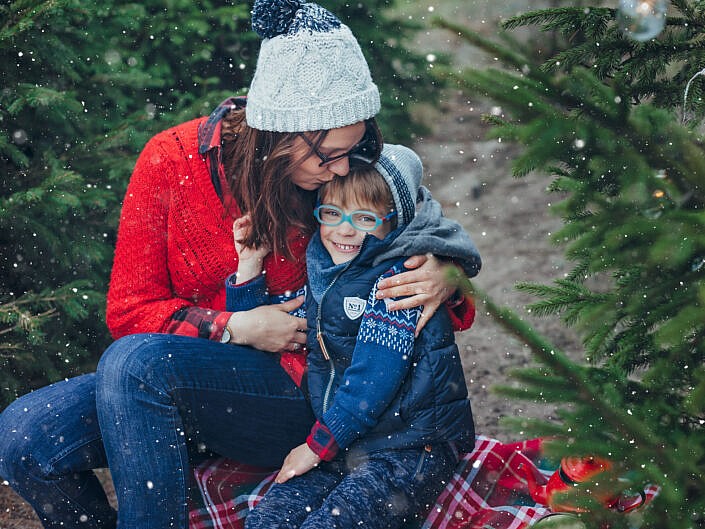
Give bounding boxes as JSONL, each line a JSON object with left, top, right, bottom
{"left": 189, "top": 436, "right": 659, "bottom": 529}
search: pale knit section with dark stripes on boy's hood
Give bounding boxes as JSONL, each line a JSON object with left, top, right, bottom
{"left": 375, "top": 143, "right": 423, "bottom": 226}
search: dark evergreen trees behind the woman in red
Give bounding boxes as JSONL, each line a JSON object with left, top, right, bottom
{"left": 0, "top": 0, "right": 442, "bottom": 406}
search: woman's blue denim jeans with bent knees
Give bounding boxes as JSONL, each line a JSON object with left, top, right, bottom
{"left": 0, "top": 334, "right": 314, "bottom": 529}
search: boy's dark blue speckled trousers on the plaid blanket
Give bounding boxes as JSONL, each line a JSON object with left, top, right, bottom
{"left": 245, "top": 443, "right": 459, "bottom": 529}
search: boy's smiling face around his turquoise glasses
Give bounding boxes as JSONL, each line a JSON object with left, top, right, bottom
{"left": 319, "top": 197, "right": 391, "bottom": 264}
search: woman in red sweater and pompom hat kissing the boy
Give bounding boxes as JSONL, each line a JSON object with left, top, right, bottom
{"left": 0, "top": 0, "right": 478, "bottom": 529}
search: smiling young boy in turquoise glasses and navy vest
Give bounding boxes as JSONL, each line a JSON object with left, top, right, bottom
{"left": 228, "top": 145, "right": 480, "bottom": 529}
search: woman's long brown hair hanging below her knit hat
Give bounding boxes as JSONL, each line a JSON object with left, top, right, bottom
{"left": 221, "top": 109, "right": 316, "bottom": 259}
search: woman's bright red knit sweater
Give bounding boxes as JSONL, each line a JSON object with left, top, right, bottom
{"left": 107, "top": 118, "right": 307, "bottom": 339}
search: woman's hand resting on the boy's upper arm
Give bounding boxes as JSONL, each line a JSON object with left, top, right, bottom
{"left": 377, "top": 254, "right": 456, "bottom": 336}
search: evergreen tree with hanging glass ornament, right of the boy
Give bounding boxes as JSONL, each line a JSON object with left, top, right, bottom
{"left": 438, "top": 0, "right": 705, "bottom": 528}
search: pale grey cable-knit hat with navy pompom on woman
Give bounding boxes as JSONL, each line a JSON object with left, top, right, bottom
{"left": 245, "top": 0, "right": 380, "bottom": 132}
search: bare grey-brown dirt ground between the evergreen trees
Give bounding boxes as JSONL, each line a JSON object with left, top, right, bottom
{"left": 0, "top": 4, "right": 577, "bottom": 529}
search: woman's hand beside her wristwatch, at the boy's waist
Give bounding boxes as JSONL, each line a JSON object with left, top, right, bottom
{"left": 228, "top": 296, "right": 306, "bottom": 353}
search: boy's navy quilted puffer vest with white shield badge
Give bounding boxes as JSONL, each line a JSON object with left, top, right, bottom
{"left": 306, "top": 236, "right": 475, "bottom": 452}
